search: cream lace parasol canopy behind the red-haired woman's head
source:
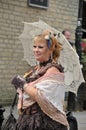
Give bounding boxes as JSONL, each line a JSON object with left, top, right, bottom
{"left": 19, "top": 20, "right": 84, "bottom": 94}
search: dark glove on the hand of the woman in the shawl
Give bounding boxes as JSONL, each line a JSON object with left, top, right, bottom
{"left": 11, "top": 75, "right": 26, "bottom": 89}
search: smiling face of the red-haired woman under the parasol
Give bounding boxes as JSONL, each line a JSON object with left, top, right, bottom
{"left": 33, "top": 42, "right": 50, "bottom": 62}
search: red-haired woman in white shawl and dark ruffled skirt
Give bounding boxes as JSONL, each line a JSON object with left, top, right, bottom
{"left": 12, "top": 30, "right": 68, "bottom": 130}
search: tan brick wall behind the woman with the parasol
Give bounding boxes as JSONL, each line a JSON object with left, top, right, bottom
{"left": 0, "top": 0, "right": 78, "bottom": 104}
